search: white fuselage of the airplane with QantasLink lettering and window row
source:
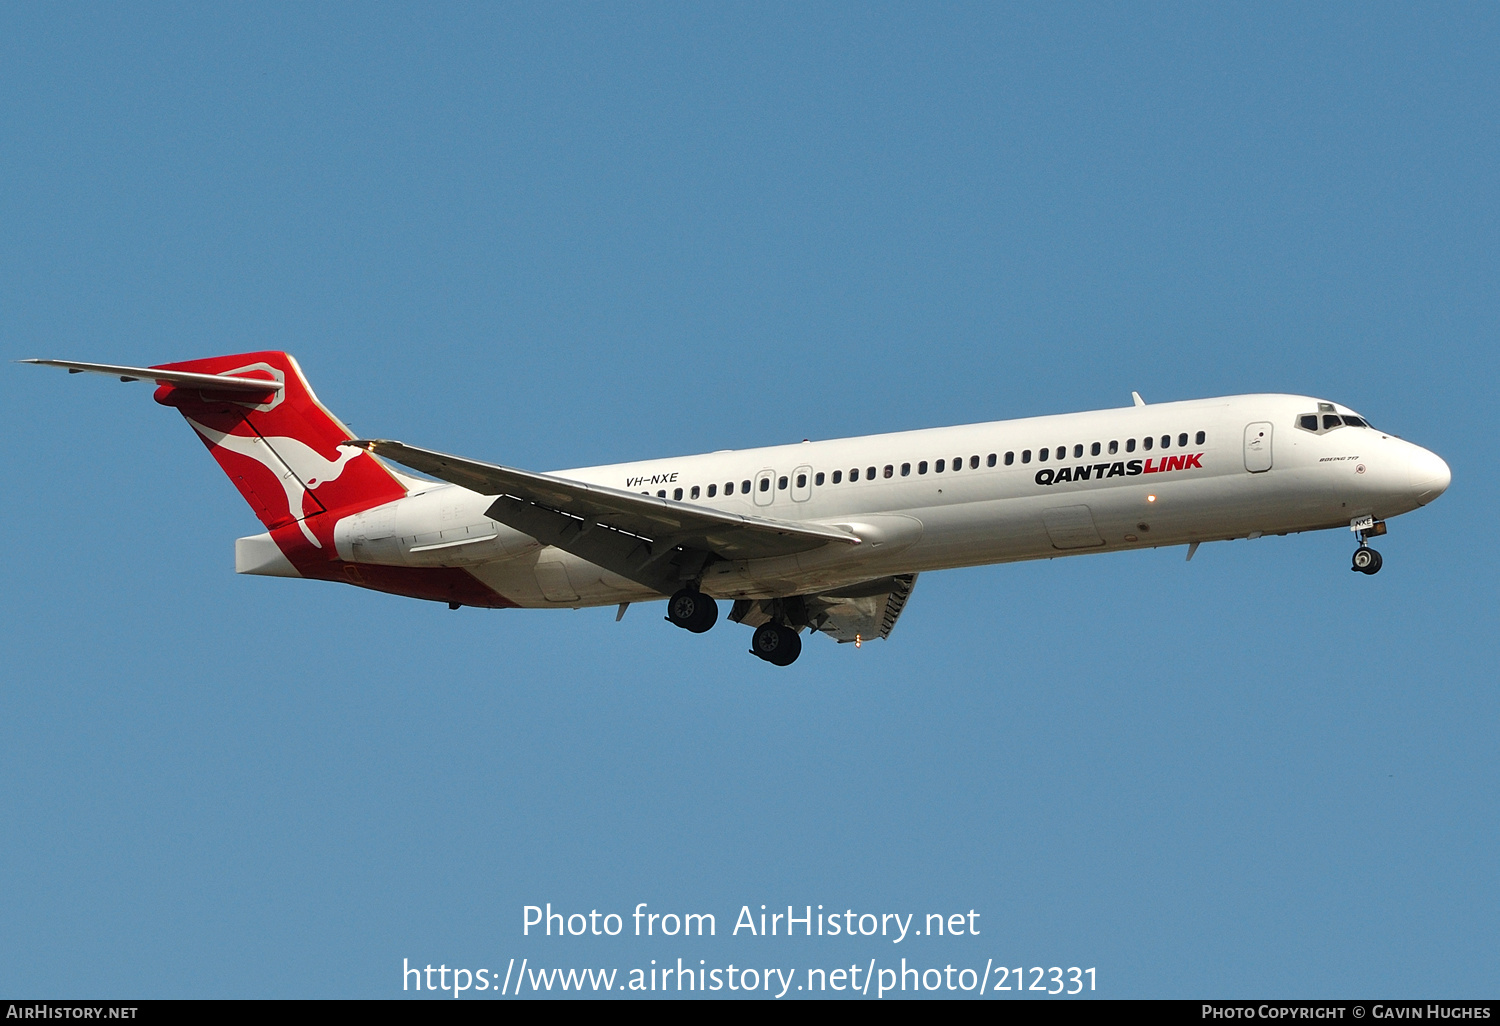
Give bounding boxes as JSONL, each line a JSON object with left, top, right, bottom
{"left": 322, "top": 395, "right": 1449, "bottom": 608}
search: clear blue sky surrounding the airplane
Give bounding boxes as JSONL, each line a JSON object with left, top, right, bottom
{"left": 0, "top": 3, "right": 1500, "bottom": 998}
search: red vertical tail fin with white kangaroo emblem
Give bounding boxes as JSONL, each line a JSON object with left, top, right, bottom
{"left": 155, "top": 353, "right": 407, "bottom": 554}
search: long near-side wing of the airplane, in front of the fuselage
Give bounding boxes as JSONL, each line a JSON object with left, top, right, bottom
{"left": 345, "top": 440, "right": 860, "bottom": 593}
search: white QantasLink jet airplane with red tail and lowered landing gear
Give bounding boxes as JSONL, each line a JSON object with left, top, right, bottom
{"left": 23, "top": 351, "right": 1452, "bottom": 666}
